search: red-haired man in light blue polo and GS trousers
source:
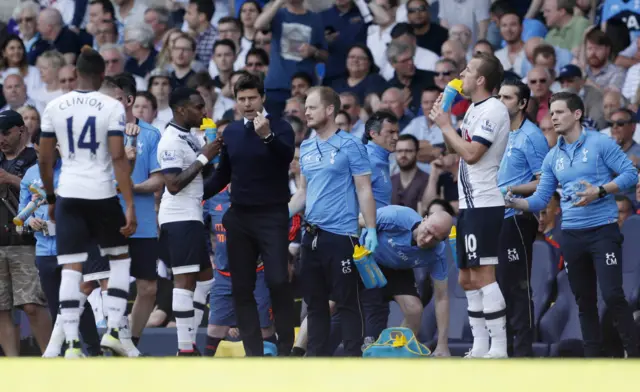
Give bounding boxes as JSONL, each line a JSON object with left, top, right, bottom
{"left": 288, "top": 87, "right": 378, "bottom": 356}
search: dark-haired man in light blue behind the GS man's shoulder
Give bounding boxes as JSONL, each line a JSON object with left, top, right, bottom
{"left": 362, "top": 111, "right": 400, "bottom": 209}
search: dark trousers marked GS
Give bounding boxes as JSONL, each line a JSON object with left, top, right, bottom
{"left": 301, "top": 230, "right": 363, "bottom": 357}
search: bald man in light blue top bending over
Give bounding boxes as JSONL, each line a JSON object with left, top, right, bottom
{"left": 362, "top": 205, "right": 453, "bottom": 356}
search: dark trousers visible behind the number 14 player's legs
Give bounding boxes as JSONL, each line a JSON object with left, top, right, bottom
{"left": 36, "top": 256, "right": 100, "bottom": 356}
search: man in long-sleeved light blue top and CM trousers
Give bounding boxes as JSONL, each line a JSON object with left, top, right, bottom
{"left": 507, "top": 92, "right": 638, "bottom": 357}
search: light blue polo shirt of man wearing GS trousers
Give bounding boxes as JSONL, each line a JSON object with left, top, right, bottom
{"left": 300, "top": 130, "right": 371, "bottom": 235}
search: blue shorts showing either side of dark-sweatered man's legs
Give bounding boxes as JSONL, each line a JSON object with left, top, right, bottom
{"left": 209, "top": 270, "right": 273, "bottom": 328}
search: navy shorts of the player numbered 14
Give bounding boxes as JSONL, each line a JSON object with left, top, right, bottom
{"left": 55, "top": 196, "right": 129, "bottom": 264}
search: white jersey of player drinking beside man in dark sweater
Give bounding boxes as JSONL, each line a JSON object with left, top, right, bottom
{"left": 158, "top": 123, "right": 204, "bottom": 225}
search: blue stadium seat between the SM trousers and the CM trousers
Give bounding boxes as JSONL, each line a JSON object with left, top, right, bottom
{"left": 540, "top": 270, "right": 582, "bottom": 343}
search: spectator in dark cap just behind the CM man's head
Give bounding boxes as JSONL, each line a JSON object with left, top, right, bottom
{"left": 558, "top": 64, "right": 607, "bottom": 129}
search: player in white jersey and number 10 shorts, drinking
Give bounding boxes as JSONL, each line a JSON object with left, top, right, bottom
{"left": 430, "top": 54, "right": 511, "bottom": 358}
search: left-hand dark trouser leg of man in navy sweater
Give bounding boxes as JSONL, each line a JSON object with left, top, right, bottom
{"left": 222, "top": 207, "right": 262, "bottom": 356}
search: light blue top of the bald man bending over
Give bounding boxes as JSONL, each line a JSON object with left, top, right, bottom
{"left": 361, "top": 205, "right": 451, "bottom": 280}
